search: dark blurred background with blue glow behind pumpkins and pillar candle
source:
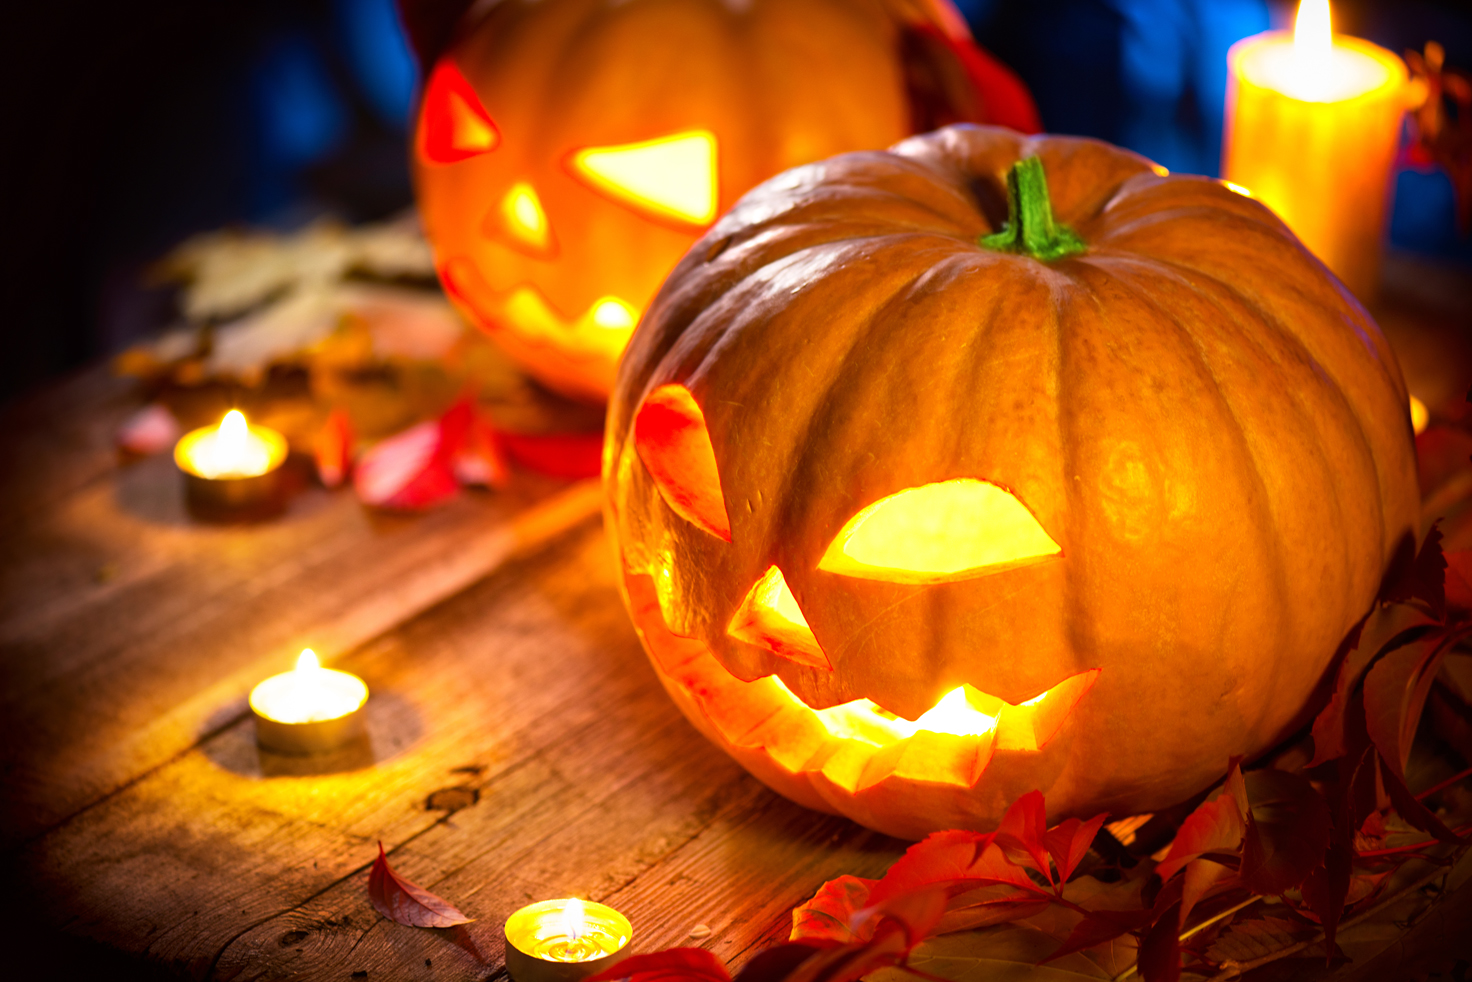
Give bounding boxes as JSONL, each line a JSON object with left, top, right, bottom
{"left": 0, "top": 0, "right": 1472, "bottom": 398}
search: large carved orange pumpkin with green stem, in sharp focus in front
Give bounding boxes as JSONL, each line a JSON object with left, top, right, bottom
{"left": 604, "top": 127, "right": 1418, "bottom": 838}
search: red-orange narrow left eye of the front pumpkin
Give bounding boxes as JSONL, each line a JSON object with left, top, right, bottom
{"left": 634, "top": 383, "right": 732, "bottom": 542}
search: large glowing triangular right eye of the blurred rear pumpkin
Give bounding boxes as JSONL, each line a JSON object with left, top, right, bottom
{"left": 568, "top": 130, "right": 718, "bottom": 225}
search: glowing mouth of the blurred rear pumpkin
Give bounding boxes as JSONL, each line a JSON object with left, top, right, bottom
{"left": 440, "top": 258, "right": 639, "bottom": 359}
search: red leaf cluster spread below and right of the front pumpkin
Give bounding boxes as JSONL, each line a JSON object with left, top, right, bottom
{"left": 604, "top": 515, "right": 1472, "bottom": 982}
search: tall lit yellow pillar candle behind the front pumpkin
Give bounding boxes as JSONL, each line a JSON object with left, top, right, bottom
{"left": 1222, "top": 0, "right": 1412, "bottom": 300}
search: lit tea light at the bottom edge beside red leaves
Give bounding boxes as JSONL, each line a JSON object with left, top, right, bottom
{"left": 506, "top": 897, "right": 634, "bottom": 982}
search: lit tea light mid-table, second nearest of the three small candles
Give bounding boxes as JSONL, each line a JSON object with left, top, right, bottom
{"left": 250, "top": 648, "right": 368, "bottom": 754}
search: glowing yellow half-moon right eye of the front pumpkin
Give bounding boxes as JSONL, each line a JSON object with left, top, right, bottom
{"left": 818, "top": 478, "right": 1063, "bottom": 583}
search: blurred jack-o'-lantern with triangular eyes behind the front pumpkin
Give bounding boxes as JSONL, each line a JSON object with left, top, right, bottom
{"left": 414, "top": 0, "right": 1036, "bottom": 402}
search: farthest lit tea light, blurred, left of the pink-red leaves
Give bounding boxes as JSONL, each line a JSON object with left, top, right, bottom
{"left": 174, "top": 409, "right": 287, "bottom": 518}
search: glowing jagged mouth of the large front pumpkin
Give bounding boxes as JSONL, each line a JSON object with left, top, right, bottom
{"left": 624, "top": 573, "right": 1100, "bottom": 794}
